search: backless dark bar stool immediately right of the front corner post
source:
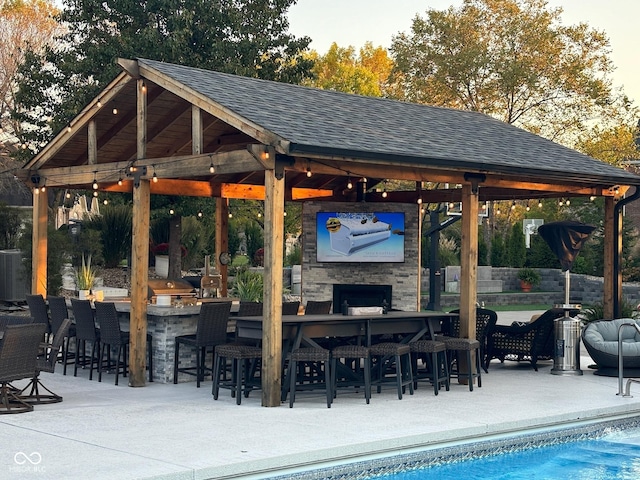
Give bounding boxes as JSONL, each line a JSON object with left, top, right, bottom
{"left": 287, "top": 347, "right": 333, "bottom": 408}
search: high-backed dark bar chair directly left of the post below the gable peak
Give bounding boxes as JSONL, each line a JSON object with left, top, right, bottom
{"left": 95, "top": 302, "right": 153, "bottom": 385}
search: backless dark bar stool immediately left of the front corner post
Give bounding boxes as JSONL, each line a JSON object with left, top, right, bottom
{"left": 211, "top": 344, "right": 262, "bottom": 405}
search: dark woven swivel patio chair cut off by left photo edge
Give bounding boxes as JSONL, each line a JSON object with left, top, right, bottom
{"left": 0, "top": 323, "right": 47, "bottom": 414}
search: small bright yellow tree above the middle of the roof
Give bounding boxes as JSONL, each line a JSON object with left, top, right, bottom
{"left": 308, "top": 42, "right": 393, "bottom": 97}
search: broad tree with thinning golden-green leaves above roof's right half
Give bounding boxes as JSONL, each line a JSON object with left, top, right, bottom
{"left": 391, "top": 0, "right": 614, "bottom": 143}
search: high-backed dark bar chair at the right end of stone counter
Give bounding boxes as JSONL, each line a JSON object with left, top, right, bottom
{"left": 173, "top": 302, "right": 231, "bottom": 388}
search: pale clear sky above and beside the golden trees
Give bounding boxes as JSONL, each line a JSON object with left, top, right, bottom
{"left": 288, "top": 0, "right": 640, "bottom": 106}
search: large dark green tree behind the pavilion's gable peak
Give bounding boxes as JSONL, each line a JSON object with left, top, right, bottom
{"left": 17, "top": 0, "right": 312, "bottom": 158}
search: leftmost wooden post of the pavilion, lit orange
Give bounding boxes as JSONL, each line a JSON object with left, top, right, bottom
{"left": 31, "top": 186, "right": 48, "bottom": 298}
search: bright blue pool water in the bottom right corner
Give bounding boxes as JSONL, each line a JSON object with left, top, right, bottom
{"left": 371, "top": 429, "right": 640, "bottom": 480}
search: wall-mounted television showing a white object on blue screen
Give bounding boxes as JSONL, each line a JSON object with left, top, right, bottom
{"left": 316, "top": 212, "right": 404, "bottom": 263}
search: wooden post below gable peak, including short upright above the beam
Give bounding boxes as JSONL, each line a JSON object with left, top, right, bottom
{"left": 129, "top": 79, "right": 151, "bottom": 387}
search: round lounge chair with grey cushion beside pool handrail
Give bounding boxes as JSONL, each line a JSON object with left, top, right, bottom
{"left": 582, "top": 318, "right": 640, "bottom": 376}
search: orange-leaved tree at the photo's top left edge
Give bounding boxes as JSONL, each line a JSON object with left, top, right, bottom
{"left": 0, "top": 0, "right": 61, "bottom": 191}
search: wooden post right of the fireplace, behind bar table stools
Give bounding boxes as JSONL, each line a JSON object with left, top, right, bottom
{"left": 458, "top": 184, "right": 478, "bottom": 383}
